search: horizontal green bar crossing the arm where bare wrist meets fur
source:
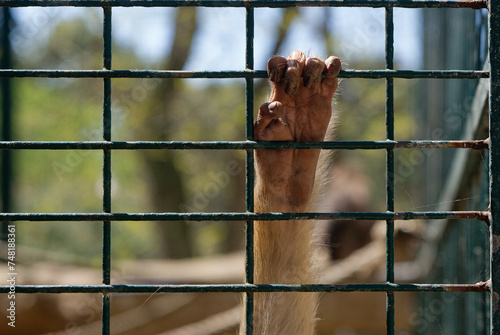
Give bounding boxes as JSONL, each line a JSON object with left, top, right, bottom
{"left": 0, "top": 211, "right": 488, "bottom": 222}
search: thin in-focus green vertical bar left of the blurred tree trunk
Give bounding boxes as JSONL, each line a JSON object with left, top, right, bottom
{"left": 102, "top": 7, "right": 111, "bottom": 335}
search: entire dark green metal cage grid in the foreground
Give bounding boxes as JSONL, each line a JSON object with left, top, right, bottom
{"left": 0, "top": 0, "right": 500, "bottom": 334}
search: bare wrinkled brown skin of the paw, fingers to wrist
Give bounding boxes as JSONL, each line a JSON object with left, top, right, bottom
{"left": 254, "top": 51, "right": 341, "bottom": 211}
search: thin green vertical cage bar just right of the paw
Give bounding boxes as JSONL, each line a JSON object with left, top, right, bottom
{"left": 385, "top": 7, "right": 395, "bottom": 335}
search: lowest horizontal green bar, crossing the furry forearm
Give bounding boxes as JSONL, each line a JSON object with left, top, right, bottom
{"left": 0, "top": 282, "right": 490, "bottom": 294}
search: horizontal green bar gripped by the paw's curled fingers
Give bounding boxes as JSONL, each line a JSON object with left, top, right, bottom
{"left": 0, "top": 69, "right": 489, "bottom": 79}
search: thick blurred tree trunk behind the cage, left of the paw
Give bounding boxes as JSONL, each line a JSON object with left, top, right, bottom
{"left": 137, "top": 8, "right": 197, "bottom": 258}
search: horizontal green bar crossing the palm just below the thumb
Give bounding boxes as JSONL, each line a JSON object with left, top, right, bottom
{"left": 0, "top": 140, "right": 488, "bottom": 150}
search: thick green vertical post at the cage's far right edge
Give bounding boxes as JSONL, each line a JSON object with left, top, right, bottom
{"left": 488, "top": 0, "right": 500, "bottom": 335}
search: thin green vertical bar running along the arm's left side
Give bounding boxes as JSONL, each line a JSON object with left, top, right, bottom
{"left": 245, "top": 7, "right": 255, "bottom": 335}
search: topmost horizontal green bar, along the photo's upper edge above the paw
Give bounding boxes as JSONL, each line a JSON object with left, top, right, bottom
{"left": 0, "top": 0, "right": 487, "bottom": 9}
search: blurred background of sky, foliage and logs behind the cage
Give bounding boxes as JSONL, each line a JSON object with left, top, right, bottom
{"left": 0, "top": 7, "right": 489, "bottom": 335}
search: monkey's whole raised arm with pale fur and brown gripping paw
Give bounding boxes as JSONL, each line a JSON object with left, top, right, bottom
{"left": 240, "top": 51, "right": 340, "bottom": 335}
